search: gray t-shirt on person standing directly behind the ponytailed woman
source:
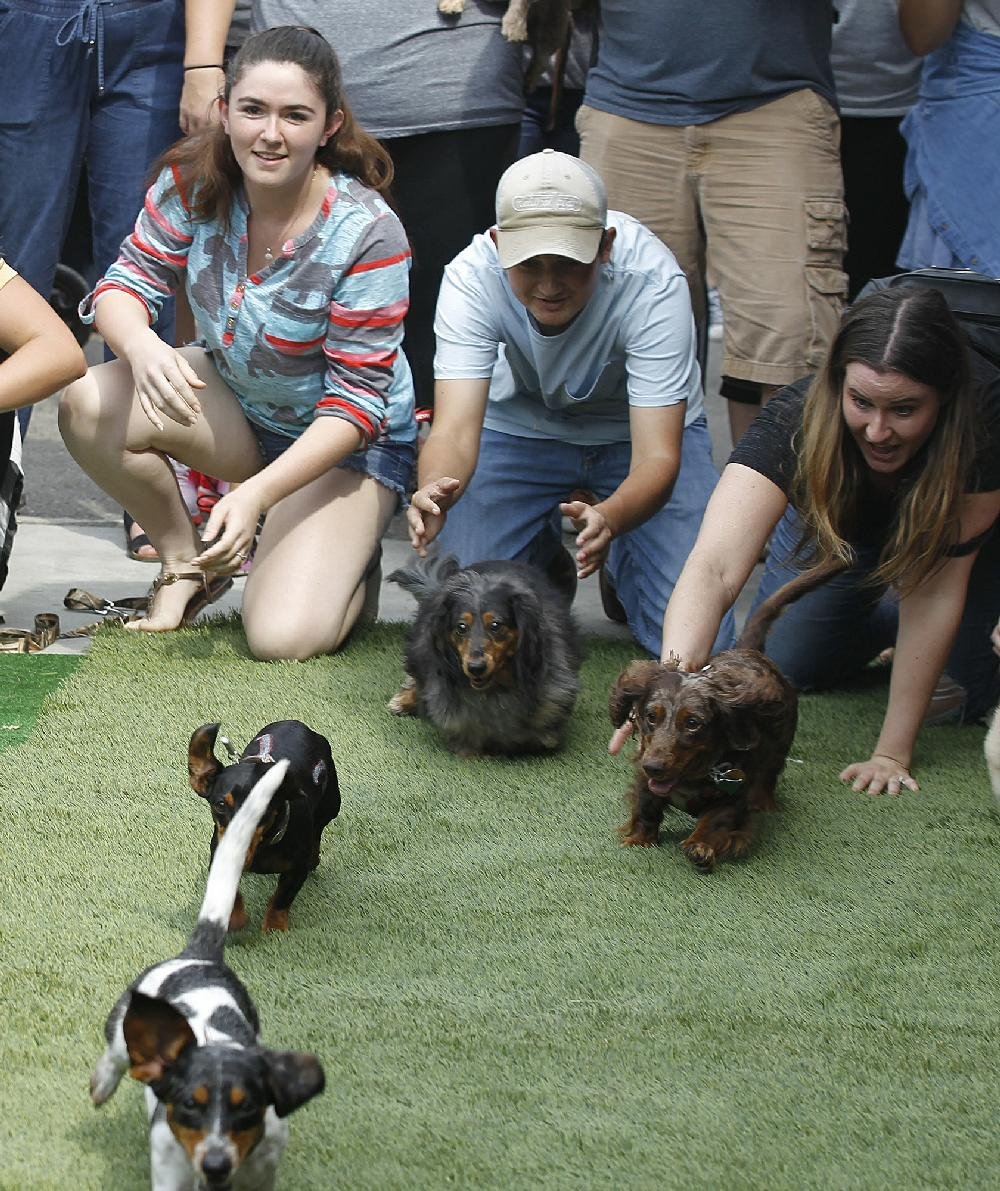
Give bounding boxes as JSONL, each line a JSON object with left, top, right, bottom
{"left": 254, "top": 0, "right": 524, "bottom": 139}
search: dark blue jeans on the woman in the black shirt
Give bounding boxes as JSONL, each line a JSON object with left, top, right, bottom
{"left": 754, "top": 506, "right": 1000, "bottom": 723}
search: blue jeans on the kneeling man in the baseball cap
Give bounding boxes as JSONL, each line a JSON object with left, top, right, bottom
{"left": 438, "top": 417, "right": 733, "bottom": 656}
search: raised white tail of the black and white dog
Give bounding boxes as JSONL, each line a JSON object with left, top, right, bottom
{"left": 185, "top": 760, "right": 289, "bottom": 959}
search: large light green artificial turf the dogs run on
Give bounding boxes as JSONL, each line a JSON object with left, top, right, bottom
{"left": 0, "top": 623, "right": 1000, "bottom": 1191}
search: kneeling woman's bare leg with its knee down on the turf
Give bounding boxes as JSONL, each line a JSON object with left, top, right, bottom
{"left": 243, "top": 467, "right": 396, "bottom": 661}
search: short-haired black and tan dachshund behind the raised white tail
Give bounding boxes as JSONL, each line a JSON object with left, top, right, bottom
{"left": 188, "top": 719, "right": 340, "bottom": 930}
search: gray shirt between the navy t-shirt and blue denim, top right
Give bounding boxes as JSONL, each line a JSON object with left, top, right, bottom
{"left": 831, "top": 0, "right": 920, "bottom": 116}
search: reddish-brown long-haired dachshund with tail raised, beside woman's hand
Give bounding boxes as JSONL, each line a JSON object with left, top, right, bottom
{"left": 608, "top": 562, "right": 843, "bottom": 872}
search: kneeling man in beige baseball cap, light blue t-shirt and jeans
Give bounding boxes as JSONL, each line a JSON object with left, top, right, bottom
{"left": 407, "top": 149, "right": 732, "bottom": 656}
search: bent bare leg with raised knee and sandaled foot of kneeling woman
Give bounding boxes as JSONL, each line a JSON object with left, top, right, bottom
{"left": 60, "top": 348, "right": 261, "bottom": 631}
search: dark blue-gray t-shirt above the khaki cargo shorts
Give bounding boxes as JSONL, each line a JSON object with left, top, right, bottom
{"left": 585, "top": 0, "right": 837, "bottom": 124}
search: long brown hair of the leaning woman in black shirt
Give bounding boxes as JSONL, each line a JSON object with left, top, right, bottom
{"left": 792, "top": 285, "right": 977, "bottom": 596}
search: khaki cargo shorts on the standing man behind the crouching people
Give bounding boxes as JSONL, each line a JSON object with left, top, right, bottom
{"left": 576, "top": 91, "right": 848, "bottom": 385}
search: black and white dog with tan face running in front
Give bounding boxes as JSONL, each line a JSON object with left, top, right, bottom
{"left": 90, "top": 761, "right": 324, "bottom": 1191}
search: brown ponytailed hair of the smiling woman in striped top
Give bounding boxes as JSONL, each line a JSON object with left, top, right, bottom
{"left": 152, "top": 25, "right": 393, "bottom": 226}
